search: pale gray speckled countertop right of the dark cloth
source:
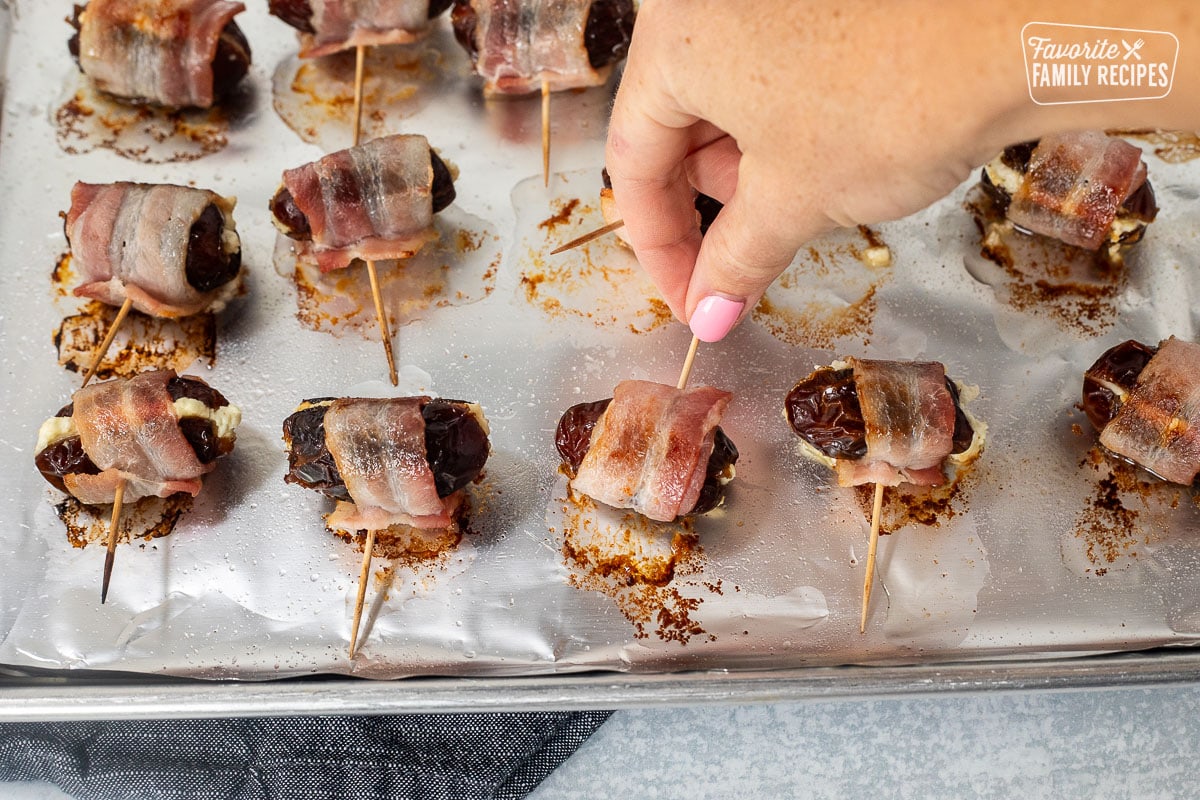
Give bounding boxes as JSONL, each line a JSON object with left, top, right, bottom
{"left": 529, "top": 687, "right": 1200, "bottom": 800}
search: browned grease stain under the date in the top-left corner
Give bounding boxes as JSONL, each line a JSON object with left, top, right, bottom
{"left": 54, "top": 86, "right": 229, "bottom": 163}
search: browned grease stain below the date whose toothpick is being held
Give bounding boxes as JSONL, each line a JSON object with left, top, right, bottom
{"left": 557, "top": 489, "right": 724, "bottom": 645}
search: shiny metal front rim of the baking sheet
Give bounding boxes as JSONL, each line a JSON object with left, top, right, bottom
{"left": 0, "top": 648, "right": 1200, "bottom": 722}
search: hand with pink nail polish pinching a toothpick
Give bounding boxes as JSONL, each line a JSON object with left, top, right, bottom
{"left": 606, "top": 0, "right": 1195, "bottom": 341}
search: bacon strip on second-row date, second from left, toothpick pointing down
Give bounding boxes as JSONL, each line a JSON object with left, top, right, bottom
{"left": 283, "top": 134, "right": 436, "bottom": 272}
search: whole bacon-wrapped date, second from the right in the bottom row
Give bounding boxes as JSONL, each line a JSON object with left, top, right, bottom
{"left": 785, "top": 359, "right": 983, "bottom": 486}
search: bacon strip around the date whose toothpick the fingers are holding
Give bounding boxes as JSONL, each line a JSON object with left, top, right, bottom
{"left": 571, "top": 380, "right": 733, "bottom": 522}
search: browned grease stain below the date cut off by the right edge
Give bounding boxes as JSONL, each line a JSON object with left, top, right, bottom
{"left": 1074, "top": 445, "right": 1184, "bottom": 577}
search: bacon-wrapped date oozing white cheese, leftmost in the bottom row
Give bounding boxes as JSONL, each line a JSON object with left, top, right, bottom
{"left": 37, "top": 371, "right": 241, "bottom": 505}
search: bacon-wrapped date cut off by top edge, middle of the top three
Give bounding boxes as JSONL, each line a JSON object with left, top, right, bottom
{"left": 268, "top": 0, "right": 452, "bottom": 59}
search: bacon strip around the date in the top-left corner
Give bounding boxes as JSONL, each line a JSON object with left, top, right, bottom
{"left": 79, "top": 0, "right": 246, "bottom": 108}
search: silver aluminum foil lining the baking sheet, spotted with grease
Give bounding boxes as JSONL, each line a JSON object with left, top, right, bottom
{"left": 0, "top": 2, "right": 1200, "bottom": 679}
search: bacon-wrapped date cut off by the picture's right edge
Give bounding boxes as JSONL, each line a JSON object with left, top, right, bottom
{"left": 1084, "top": 337, "right": 1200, "bottom": 485}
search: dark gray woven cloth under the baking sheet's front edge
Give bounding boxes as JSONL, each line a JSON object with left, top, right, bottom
{"left": 0, "top": 711, "right": 612, "bottom": 800}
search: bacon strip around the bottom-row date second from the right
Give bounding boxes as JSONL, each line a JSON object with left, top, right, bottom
{"left": 836, "top": 359, "right": 954, "bottom": 486}
